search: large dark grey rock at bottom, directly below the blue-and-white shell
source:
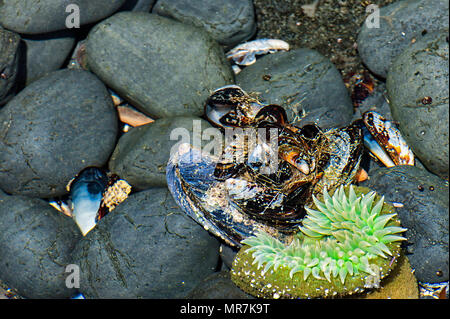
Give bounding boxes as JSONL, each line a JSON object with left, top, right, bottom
{"left": 73, "top": 188, "right": 219, "bottom": 298}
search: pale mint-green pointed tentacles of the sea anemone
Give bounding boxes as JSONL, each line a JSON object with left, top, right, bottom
{"left": 232, "top": 185, "right": 406, "bottom": 300}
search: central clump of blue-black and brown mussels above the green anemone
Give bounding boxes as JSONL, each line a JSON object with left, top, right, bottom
{"left": 166, "top": 85, "right": 363, "bottom": 247}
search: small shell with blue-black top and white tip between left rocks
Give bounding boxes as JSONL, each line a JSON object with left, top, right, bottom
{"left": 69, "top": 167, "right": 108, "bottom": 235}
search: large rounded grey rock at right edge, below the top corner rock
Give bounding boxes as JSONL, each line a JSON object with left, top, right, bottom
{"left": 386, "top": 31, "right": 449, "bottom": 176}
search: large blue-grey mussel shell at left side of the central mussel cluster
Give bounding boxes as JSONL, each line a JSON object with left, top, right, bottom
{"left": 166, "top": 144, "right": 294, "bottom": 247}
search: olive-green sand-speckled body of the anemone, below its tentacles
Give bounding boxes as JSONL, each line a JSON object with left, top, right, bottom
{"left": 231, "top": 187, "right": 400, "bottom": 299}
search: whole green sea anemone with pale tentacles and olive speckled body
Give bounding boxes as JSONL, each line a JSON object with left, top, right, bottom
{"left": 231, "top": 186, "right": 406, "bottom": 298}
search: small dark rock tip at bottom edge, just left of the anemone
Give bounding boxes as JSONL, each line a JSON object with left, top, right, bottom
{"left": 186, "top": 271, "right": 254, "bottom": 299}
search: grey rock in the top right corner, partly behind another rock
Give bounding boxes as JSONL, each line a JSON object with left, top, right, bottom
{"left": 358, "top": 0, "right": 449, "bottom": 78}
